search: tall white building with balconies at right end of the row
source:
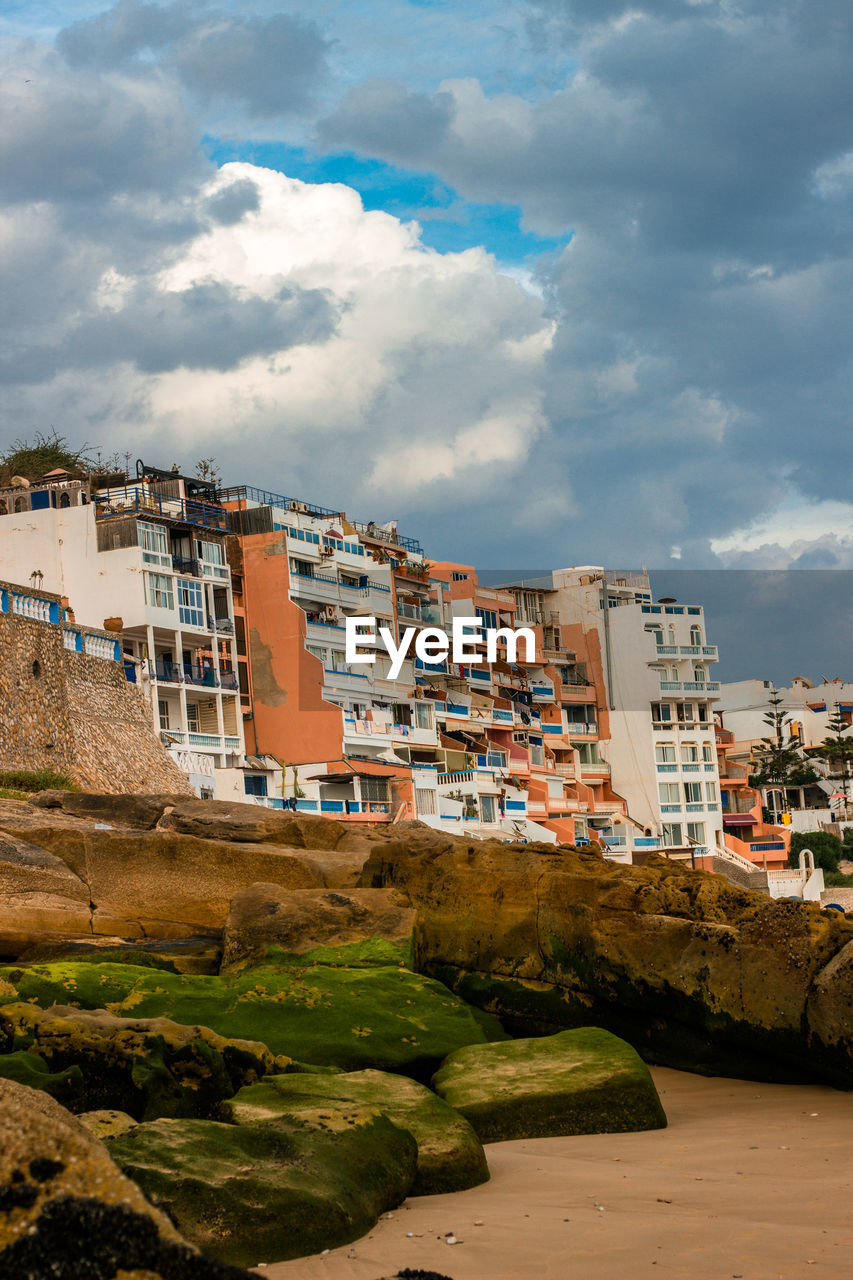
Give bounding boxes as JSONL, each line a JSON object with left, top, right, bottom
{"left": 552, "top": 567, "right": 722, "bottom": 856}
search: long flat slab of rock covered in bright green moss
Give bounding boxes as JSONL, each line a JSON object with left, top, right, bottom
{"left": 0, "top": 963, "right": 505, "bottom": 1080}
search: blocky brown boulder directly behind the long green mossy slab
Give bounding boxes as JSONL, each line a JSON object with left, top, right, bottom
{"left": 222, "top": 884, "right": 415, "bottom": 973}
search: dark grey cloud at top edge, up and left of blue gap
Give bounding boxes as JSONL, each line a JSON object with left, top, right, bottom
{"left": 56, "top": 0, "right": 329, "bottom": 116}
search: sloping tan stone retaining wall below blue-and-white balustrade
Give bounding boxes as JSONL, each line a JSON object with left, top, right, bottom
{"left": 0, "top": 599, "right": 192, "bottom": 795}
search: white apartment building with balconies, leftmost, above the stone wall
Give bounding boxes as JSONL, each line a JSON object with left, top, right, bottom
{"left": 0, "top": 463, "right": 245, "bottom": 796}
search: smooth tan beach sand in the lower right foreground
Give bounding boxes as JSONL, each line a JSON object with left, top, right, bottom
{"left": 259, "top": 1069, "right": 853, "bottom": 1280}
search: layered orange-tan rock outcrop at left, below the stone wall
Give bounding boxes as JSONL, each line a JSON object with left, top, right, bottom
{"left": 0, "top": 791, "right": 391, "bottom": 959}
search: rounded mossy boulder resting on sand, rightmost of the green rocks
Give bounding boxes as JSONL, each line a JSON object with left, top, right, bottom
{"left": 432, "top": 1027, "right": 666, "bottom": 1142}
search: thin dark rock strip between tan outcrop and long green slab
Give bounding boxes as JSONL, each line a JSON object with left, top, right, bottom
{"left": 17, "top": 933, "right": 222, "bottom": 973}
